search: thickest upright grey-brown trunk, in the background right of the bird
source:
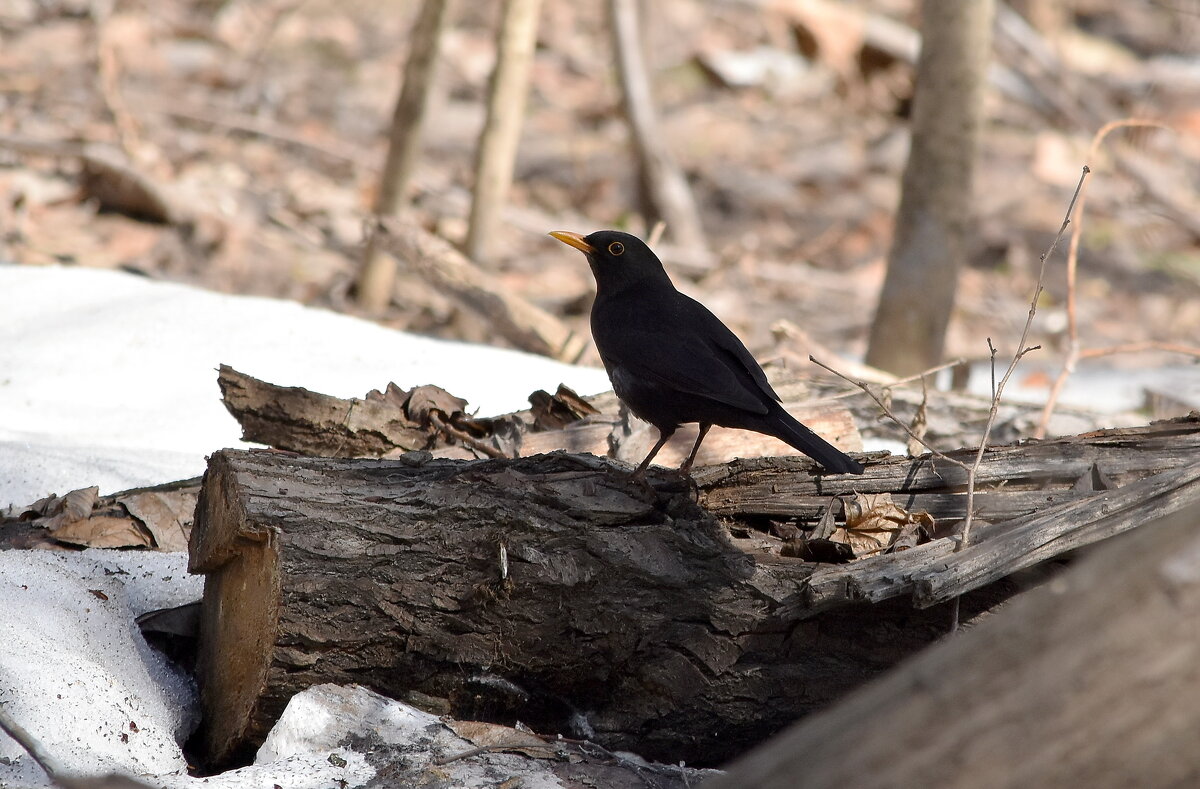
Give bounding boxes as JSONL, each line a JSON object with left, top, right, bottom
{"left": 866, "top": 0, "right": 992, "bottom": 375}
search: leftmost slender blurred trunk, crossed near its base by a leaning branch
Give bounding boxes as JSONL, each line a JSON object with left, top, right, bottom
{"left": 356, "top": 0, "right": 448, "bottom": 312}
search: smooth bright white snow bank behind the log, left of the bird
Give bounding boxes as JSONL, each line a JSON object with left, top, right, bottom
{"left": 0, "top": 257, "right": 610, "bottom": 507}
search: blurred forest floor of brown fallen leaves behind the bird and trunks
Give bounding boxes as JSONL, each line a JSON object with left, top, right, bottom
{"left": 0, "top": 0, "right": 1200, "bottom": 393}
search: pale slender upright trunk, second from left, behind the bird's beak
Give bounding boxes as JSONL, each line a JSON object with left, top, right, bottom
{"left": 463, "top": 0, "right": 541, "bottom": 261}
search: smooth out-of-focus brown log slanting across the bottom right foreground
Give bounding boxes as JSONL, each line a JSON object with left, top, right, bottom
{"left": 703, "top": 498, "right": 1200, "bottom": 789}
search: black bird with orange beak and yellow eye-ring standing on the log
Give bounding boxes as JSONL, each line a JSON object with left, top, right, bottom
{"left": 550, "top": 230, "right": 863, "bottom": 477}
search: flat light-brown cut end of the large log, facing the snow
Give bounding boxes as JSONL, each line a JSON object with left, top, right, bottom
{"left": 188, "top": 452, "right": 281, "bottom": 763}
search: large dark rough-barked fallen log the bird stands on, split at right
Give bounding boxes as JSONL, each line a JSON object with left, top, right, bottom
{"left": 191, "top": 420, "right": 1200, "bottom": 764}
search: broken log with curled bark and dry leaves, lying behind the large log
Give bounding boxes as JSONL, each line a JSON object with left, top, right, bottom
{"left": 217, "top": 365, "right": 862, "bottom": 466}
